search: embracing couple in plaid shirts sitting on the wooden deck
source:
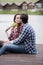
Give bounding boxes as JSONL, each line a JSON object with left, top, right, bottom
{"left": 0, "top": 13, "right": 37, "bottom": 56}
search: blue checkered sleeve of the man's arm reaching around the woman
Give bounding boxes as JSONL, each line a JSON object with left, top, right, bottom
{"left": 11, "top": 27, "right": 27, "bottom": 44}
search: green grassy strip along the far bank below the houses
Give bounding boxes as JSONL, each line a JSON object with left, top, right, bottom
{"left": 0, "top": 10, "right": 43, "bottom": 15}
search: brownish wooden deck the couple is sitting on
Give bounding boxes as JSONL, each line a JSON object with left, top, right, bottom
{"left": 0, "top": 44, "right": 43, "bottom": 65}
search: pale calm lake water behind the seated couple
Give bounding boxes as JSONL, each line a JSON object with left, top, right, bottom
{"left": 0, "top": 14, "right": 43, "bottom": 44}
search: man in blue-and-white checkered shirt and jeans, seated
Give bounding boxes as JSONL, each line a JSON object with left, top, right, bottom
{"left": 0, "top": 14, "right": 37, "bottom": 55}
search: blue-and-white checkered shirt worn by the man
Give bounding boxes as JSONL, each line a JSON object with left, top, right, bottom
{"left": 12, "top": 23, "right": 36, "bottom": 54}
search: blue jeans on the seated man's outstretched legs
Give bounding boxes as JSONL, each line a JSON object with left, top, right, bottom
{"left": 0, "top": 44, "right": 25, "bottom": 55}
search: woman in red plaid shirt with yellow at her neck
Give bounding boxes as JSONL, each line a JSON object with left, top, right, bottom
{"left": 0, "top": 14, "right": 22, "bottom": 47}
